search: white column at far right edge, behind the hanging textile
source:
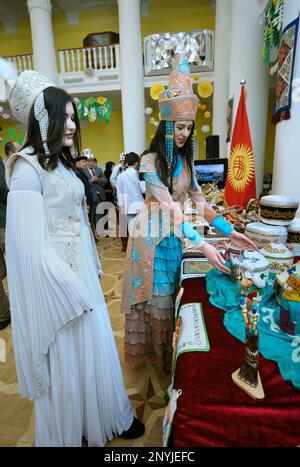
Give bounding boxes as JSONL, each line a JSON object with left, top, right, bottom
{"left": 272, "top": 0, "right": 300, "bottom": 216}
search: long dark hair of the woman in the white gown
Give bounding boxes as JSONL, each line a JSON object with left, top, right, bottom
{"left": 23, "top": 87, "right": 81, "bottom": 170}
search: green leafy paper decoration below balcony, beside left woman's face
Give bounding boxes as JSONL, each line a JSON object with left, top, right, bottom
{"left": 76, "top": 96, "right": 112, "bottom": 123}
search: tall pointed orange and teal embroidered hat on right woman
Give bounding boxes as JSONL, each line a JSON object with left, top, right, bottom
{"left": 158, "top": 54, "right": 199, "bottom": 121}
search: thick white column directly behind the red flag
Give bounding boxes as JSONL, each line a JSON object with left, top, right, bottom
{"left": 227, "top": 0, "right": 269, "bottom": 196}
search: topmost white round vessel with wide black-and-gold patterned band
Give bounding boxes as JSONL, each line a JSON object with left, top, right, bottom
{"left": 259, "top": 195, "right": 299, "bottom": 225}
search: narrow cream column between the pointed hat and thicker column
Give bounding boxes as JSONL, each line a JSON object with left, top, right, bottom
{"left": 213, "top": 0, "right": 232, "bottom": 157}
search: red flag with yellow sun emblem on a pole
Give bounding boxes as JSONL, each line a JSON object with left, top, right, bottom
{"left": 224, "top": 85, "right": 256, "bottom": 207}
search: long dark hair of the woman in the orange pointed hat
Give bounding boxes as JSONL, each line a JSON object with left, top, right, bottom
{"left": 149, "top": 120, "right": 195, "bottom": 194}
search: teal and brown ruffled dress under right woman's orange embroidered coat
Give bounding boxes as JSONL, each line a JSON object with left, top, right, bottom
{"left": 125, "top": 157, "right": 183, "bottom": 371}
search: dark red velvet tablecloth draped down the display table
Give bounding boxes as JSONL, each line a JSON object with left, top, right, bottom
{"left": 173, "top": 279, "right": 300, "bottom": 447}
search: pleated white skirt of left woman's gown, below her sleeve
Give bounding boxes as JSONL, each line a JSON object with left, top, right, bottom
{"left": 35, "top": 222, "right": 133, "bottom": 447}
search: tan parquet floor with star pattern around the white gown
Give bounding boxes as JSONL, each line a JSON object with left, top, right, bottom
{"left": 0, "top": 239, "right": 170, "bottom": 447}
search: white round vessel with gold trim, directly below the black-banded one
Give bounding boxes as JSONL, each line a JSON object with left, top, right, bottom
{"left": 245, "top": 222, "right": 287, "bottom": 248}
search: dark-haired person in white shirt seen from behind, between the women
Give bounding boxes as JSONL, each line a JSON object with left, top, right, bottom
{"left": 116, "top": 152, "right": 145, "bottom": 251}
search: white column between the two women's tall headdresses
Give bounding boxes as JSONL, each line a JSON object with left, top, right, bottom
{"left": 118, "top": 0, "right": 146, "bottom": 154}
